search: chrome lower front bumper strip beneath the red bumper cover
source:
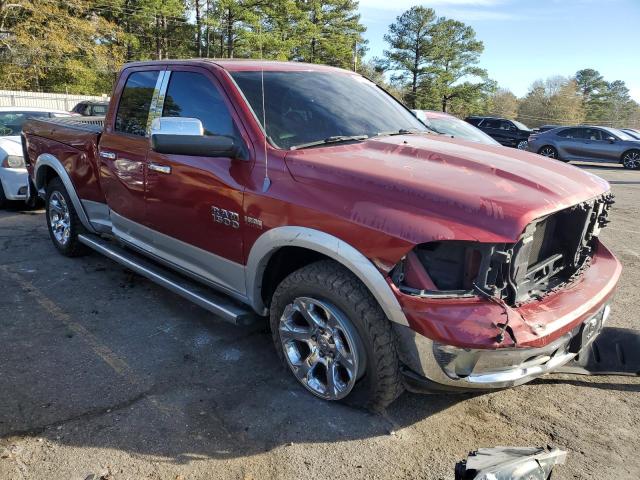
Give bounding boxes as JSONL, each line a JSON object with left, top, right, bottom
{"left": 394, "top": 304, "right": 610, "bottom": 390}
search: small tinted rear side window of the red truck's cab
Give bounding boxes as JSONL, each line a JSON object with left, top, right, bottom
{"left": 115, "top": 71, "right": 160, "bottom": 137}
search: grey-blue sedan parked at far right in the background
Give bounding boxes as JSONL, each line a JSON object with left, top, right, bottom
{"left": 528, "top": 126, "right": 640, "bottom": 168}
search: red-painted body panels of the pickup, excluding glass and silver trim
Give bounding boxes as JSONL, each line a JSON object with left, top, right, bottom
{"left": 25, "top": 60, "right": 620, "bottom": 348}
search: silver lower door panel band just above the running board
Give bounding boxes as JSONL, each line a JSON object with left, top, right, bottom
{"left": 110, "top": 210, "right": 250, "bottom": 304}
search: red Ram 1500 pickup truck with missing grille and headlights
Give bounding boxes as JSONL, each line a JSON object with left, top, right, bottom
{"left": 23, "top": 60, "right": 621, "bottom": 409}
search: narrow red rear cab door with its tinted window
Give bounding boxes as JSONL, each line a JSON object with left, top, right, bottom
{"left": 98, "top": 67, "right": 163, "bottom": 228}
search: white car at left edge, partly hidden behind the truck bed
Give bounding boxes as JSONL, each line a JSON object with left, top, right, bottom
{"left": 0, "top": 107, "right": 71, "bottom": 208}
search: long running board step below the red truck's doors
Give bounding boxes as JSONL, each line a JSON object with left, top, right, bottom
{"left": 78, "top": 234, "right": 258, "bottom": 326}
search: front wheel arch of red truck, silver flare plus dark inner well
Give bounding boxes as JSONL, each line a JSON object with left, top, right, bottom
{"left": 246, "top": 226, "right": 408, "bottom": 326}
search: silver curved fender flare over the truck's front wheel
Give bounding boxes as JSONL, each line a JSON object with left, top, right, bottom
{"left": 245, "top": 226, "right": 409, "bottom": 325}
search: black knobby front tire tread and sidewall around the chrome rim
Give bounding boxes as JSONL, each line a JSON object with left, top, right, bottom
{"left": 270, "top": 260, "right": 403, "bottom": 412}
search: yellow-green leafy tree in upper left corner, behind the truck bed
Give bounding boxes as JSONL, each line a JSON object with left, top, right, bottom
{"left": 0, "top": 0, "right": 124, "bottom": 93}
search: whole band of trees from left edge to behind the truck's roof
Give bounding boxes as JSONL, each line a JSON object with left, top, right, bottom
{"left": 0, "top": 0, "right": 366, "bottom": 94}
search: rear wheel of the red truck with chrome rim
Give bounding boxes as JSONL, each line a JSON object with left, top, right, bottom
{"left": 45, "top": 177, "right": 90, "bottom": 257}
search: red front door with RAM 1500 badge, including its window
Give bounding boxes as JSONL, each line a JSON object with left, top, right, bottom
{"left": 146, "top": 66, "right": 252, "bottom": 293}
